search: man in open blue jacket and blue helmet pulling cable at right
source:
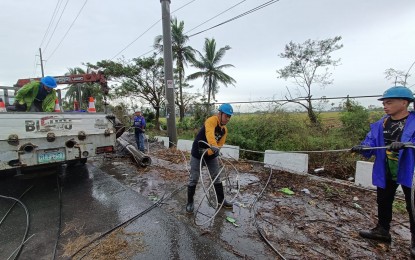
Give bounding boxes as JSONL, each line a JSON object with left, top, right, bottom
{"left": 351, "top": 86, "right": 415, "bottom": 257}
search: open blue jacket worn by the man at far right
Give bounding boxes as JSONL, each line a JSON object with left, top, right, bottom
{"left": 361, "top": 111, "right": 415, "bottom": 188}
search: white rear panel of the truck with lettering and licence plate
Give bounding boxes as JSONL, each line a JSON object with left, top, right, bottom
{"left": 0, "top": 112, "right": 116, "bottom": 171}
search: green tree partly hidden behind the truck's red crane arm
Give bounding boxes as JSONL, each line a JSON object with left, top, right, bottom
{"left": 65, "top": 67, "right": 104, "bottom": 111}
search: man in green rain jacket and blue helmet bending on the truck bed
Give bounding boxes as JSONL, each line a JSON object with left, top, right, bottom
{"left": 15, "top": 76, "right": 57, "bottom": 112}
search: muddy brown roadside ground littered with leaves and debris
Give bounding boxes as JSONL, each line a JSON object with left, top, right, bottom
{"left": 103, "top": 135, "right": 410, "bottom": 259}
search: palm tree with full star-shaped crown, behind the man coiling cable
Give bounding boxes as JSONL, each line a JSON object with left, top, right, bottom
{"left": 187, "top": 38, "right": 236, "bottom": 113}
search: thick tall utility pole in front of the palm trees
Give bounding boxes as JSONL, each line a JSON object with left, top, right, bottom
{"left": 160, "top": 0, "right": 177, "bottom": 147}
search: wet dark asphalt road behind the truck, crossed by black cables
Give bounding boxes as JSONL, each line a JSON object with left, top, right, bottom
{"left": 0, "top": 163, "right": 239, "bottom": 259}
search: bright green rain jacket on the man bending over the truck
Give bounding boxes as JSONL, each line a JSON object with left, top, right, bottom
{"left": 15, "top": 81, "right": 56, "bottom": 112}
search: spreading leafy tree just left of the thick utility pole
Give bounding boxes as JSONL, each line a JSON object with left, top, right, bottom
{"left": 90, "top": 54, "right": 164, "bottom": 129}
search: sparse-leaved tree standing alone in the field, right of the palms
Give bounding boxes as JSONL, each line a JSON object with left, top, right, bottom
{"left": 277, "top": 36, "right": 343, "bottom": 125}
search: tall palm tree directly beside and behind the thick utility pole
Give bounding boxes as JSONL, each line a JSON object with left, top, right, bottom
{"left": 154, "top": 18, "right": 196, "bottom": 121}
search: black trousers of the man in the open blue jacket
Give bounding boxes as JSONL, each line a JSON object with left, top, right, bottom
{"left": 377, "top": 180, "right": 415, "bottom": 235}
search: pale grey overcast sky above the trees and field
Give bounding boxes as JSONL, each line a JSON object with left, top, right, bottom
{"left": 0, "top": 0, "right": 415, "bottom": 109}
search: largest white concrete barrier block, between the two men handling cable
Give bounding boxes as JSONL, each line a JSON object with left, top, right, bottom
{"left": 264, "top": 150, "right": 308, "bottom": 173}
